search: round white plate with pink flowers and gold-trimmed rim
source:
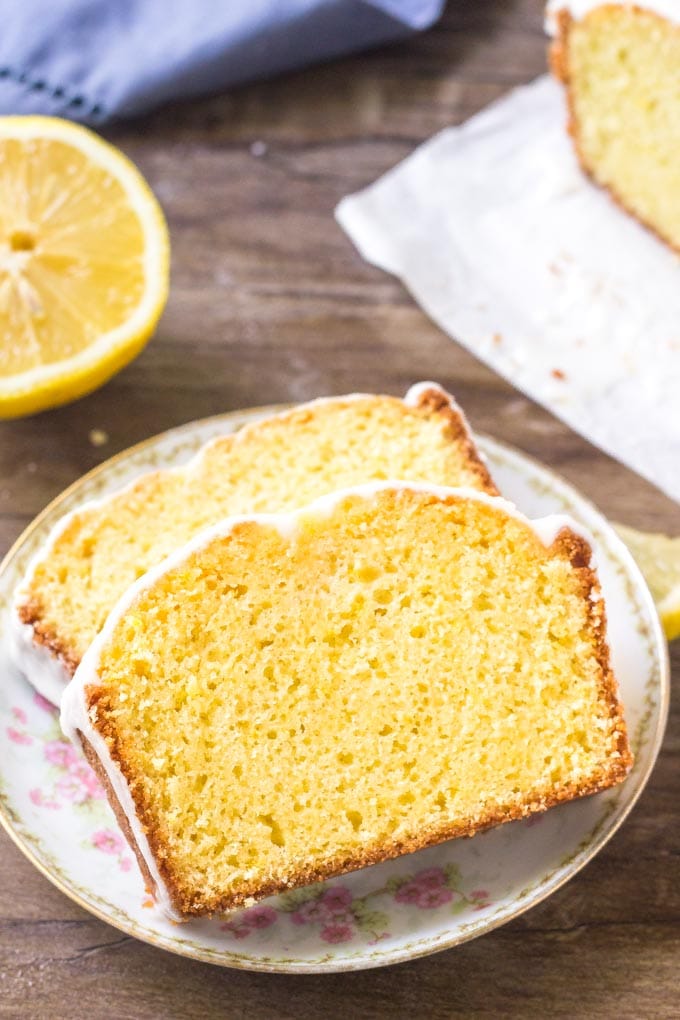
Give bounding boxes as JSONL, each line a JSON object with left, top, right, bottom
{"left": 0, "top": 408, "right": 669, "bottom": 971}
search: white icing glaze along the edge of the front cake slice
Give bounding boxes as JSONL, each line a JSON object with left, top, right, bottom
{"left": 61, "top": 481, "right": 592, "bottom": 920}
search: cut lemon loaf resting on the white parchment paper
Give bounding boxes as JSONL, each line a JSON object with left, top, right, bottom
{"left": 547, "top": 0, "right": 680, "bottom": 251}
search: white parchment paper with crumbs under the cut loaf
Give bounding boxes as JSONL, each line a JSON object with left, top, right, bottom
{"left": 336, "top": 77, "right": 680, "bottom": 501}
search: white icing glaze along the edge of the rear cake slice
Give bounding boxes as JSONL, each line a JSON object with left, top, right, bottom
{"left": 9, "top": 383, "right": 470, "bottom": 706}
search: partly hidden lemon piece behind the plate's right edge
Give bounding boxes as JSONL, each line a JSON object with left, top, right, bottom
{"left": 616, "top": 524, "right": 680, "bottom": 641}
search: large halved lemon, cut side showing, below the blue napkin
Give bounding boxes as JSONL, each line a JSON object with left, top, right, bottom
{"left": 0, "top": 116, "right": 169, "bottom": 418}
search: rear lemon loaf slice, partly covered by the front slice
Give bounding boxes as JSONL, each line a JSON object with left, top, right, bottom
{"left": 14, "top": 383, "right": 495, "bottom": 704}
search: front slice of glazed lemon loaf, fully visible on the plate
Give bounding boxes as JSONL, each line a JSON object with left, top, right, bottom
{"left": 61, "top": 481, "right": 631, "bottom": 916}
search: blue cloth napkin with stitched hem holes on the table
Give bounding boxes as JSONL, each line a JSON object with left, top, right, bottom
{"left": 0, "top": 0, "right": 446, "bottom": 122}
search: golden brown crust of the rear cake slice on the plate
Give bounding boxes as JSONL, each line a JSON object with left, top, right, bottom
{"left": 17, "top": 385, "right": 500, "bottom": 676}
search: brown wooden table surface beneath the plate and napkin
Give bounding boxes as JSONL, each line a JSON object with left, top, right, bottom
{"left": 0, "top": 0, "right": 680, "bottom": 1020}
